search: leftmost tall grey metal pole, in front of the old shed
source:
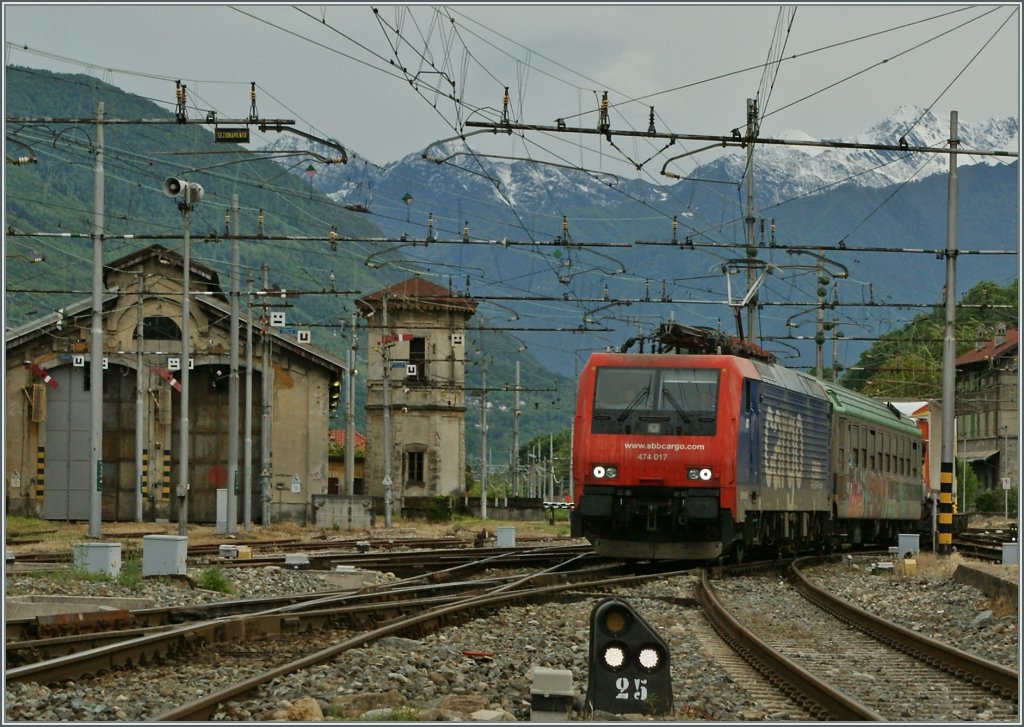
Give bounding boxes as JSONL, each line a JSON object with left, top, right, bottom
{"left": 89, "top": 101, "right": 103, "bottom": 538}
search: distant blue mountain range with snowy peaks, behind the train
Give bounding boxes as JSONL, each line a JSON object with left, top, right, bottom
{"left": 264, "top": 106, "right": 1020, "bottom": 372}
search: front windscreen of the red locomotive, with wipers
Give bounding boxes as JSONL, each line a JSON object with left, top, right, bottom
{"left": 591, "top": 367, "right": 718, "bottom": 436}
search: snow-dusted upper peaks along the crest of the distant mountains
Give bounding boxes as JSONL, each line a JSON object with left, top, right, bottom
{"left": 268, "top": 105, "right": 1020, "bottom": 218}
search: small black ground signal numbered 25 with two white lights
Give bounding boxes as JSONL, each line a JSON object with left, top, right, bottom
{"left": 587, "top": 598, "right": 673, "bottom": 715}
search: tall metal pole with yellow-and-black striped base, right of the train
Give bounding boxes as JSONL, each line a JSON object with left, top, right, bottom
{"left": 936, "top": 111, "right": 958, "bottom": 555}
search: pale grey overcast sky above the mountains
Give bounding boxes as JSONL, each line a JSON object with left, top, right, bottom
{"left": 4, "top": 3, "right": 1021, "bottom": 176}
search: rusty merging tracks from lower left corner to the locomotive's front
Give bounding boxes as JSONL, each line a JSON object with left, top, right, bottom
{"left": 6, "top": 549, "right": 688, "bottom": 721}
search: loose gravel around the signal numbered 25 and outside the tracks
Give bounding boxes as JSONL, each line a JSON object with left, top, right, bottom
{"left": 5, "top": 564, "right": 1019, "bottom": 722}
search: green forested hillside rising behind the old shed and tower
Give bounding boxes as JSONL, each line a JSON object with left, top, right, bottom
{"left": 4, "top": 67, "right": 574, "bottom": 461}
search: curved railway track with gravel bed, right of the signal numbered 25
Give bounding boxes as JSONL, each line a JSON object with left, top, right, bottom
{"left": 697, "top": 559, "right": 1019, "bottom": 722}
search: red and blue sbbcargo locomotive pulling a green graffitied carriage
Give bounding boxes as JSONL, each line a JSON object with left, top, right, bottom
{"left": 570, "top": 324, "right": 929, "bottom": 561}
